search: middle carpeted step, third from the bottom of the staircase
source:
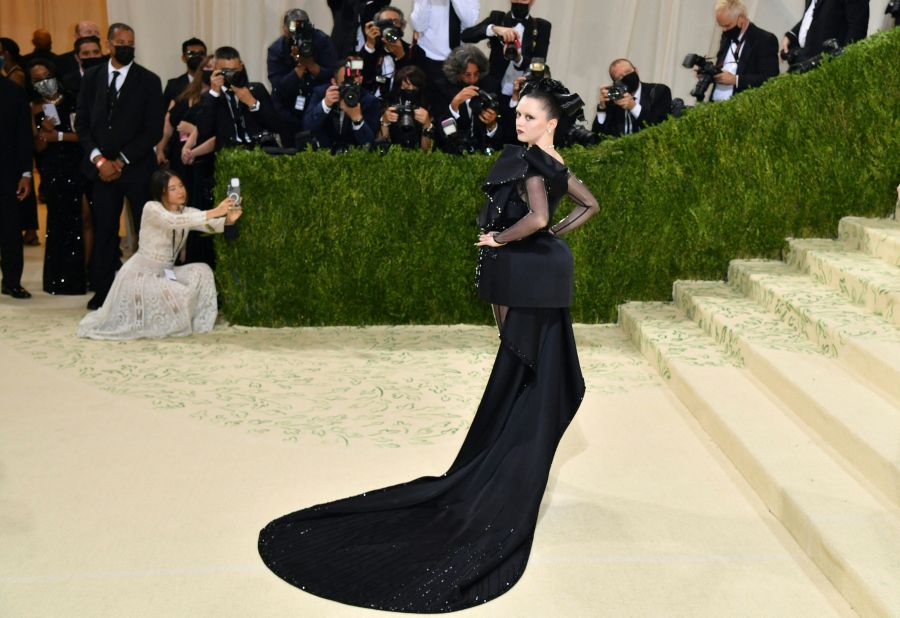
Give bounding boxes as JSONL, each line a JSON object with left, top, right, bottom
{"left": 728, "top": 260, "right": 900, "bottom": 406}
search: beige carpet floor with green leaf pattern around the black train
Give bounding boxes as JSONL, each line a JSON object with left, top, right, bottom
{"left": 0, "top": 238, "right": 852, "bottom": 618}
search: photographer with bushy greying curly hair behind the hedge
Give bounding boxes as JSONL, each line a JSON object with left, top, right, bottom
{"left": 434, "top": 43, "right": 502, "bottom": 153}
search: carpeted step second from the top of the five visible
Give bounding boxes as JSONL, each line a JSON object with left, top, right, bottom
{"left": 788, "top": 239, "right": 900, "bottom": 325}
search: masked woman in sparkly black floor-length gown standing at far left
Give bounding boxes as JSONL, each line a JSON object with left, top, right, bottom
{"left": 28, "top": 59, "right": 87, "bottom": 294}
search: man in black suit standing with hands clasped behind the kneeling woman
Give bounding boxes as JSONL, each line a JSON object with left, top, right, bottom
{"left": 75, "top": 23, "right": 164, "bottom": 309}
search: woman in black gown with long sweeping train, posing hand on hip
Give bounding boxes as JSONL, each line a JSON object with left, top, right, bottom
{"left": 259, "top": 80, "right": 598, "bottom": 613}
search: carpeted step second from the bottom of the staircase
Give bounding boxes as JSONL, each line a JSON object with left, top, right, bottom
{"left": 673, "top": 281, "right": 900, "bottom": 506}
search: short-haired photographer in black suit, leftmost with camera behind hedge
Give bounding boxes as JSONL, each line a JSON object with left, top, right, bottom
{"left": 201, "top": 47, "right": 283, "bottom": 150}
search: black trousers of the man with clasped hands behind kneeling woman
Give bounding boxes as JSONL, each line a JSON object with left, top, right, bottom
{"left": 91, "top": 170, "right": 152, "bottom": 296}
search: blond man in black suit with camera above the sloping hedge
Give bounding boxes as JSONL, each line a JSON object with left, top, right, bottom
{"left": 710, "top": 0, "right": 779, "bottom": 101}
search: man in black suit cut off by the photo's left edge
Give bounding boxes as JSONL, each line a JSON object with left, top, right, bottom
{"left": 0, "top": 67, "right": 33, "bottom": 298}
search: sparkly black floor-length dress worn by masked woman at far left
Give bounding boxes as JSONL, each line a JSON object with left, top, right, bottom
{"left": 38, "top": 93, "right": 87, "bottom": 294}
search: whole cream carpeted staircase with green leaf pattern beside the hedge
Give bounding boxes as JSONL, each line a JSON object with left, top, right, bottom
{"left": 619, "top": 217, "right": 900, "bottom": 617}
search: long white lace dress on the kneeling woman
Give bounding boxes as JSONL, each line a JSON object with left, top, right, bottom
{"left": 78, "top": 202, "right": 225, "bottom": 339}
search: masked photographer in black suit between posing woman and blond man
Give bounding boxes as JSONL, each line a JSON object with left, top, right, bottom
{"left": 593, "top": 58, "right": 672, "bottom": 137}
